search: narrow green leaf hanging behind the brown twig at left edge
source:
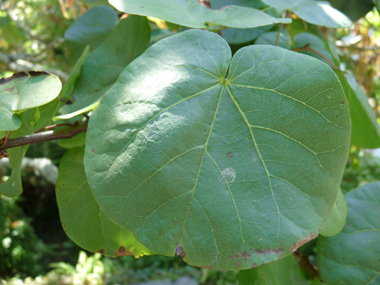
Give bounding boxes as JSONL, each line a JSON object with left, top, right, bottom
{"left": 0, "top": 108, "right": 40, "bottom": 197}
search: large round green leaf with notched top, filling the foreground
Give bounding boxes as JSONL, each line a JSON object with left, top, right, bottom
{"left": 85, "top": 30, "right": 350, "bottom": 269}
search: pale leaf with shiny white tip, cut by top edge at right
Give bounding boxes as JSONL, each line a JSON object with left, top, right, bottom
{"left": 262, "top": 0, "right": 352, "bottom": 28}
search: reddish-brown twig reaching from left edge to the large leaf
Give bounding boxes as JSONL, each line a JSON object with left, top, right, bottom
{"left": 0, "top": 124, "right": 87, "bottom": 151}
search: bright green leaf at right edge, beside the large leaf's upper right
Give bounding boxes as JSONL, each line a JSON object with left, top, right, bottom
{"left": 337, "top": 71, "right": 380, "bottom": 148}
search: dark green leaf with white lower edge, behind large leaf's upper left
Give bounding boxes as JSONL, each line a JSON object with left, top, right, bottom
{"left": 58, "top": 16, "right": 150, "bottom": 118}
